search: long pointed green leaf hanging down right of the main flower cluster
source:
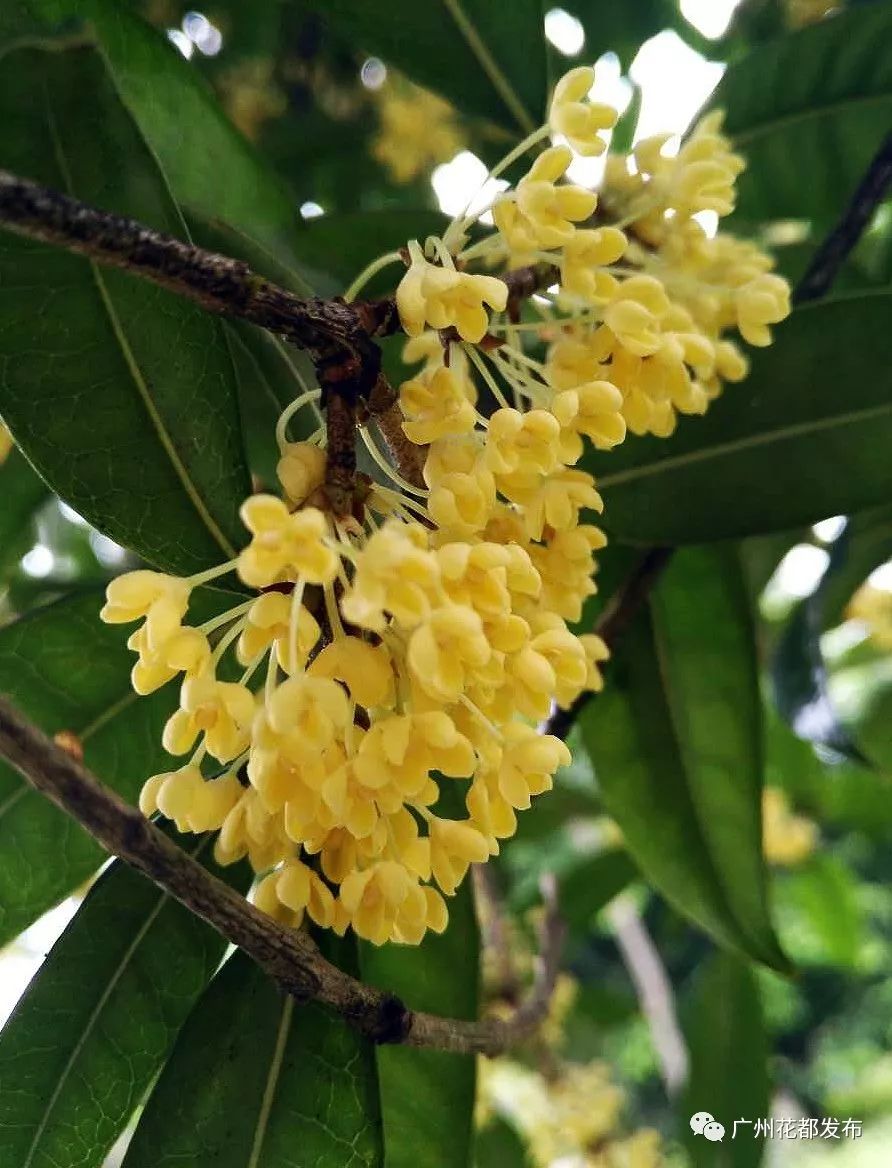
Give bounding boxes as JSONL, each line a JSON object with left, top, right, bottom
{"left": 581, "top": 548, "right": 786, "bottom": 967}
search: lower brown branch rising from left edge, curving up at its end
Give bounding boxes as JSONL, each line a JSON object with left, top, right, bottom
{"left": 0, "top": 697, "right": 563, "bottom": 1055}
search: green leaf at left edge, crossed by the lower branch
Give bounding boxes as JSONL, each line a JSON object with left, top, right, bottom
{"left": 0, "top": 590, "right": 237, "bottom": 945}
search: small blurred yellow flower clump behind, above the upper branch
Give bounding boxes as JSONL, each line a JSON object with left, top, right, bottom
{"left": 371, "top": 77, "right": 464, "bottom": 183}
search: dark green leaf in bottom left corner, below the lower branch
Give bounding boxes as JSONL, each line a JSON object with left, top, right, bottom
{"left": 0, "top": 836, "right": 248, "bottom": 1168}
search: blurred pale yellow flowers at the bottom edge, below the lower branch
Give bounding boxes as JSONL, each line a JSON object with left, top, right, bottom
{"left": 478, "top": 1058, "right": 665, "bottom": 1168}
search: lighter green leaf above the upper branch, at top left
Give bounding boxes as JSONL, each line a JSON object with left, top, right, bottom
{"left": 23, "top": 0, "right": 310, "bottom": 277}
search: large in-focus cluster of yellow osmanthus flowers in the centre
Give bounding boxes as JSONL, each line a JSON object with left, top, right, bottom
{"left": 103, "top": 61, "right": 788, "bottom": 944}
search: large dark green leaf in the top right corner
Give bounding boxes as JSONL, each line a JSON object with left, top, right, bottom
{"left": 710, "top": 2, "right": 892, "bottom": 225}
